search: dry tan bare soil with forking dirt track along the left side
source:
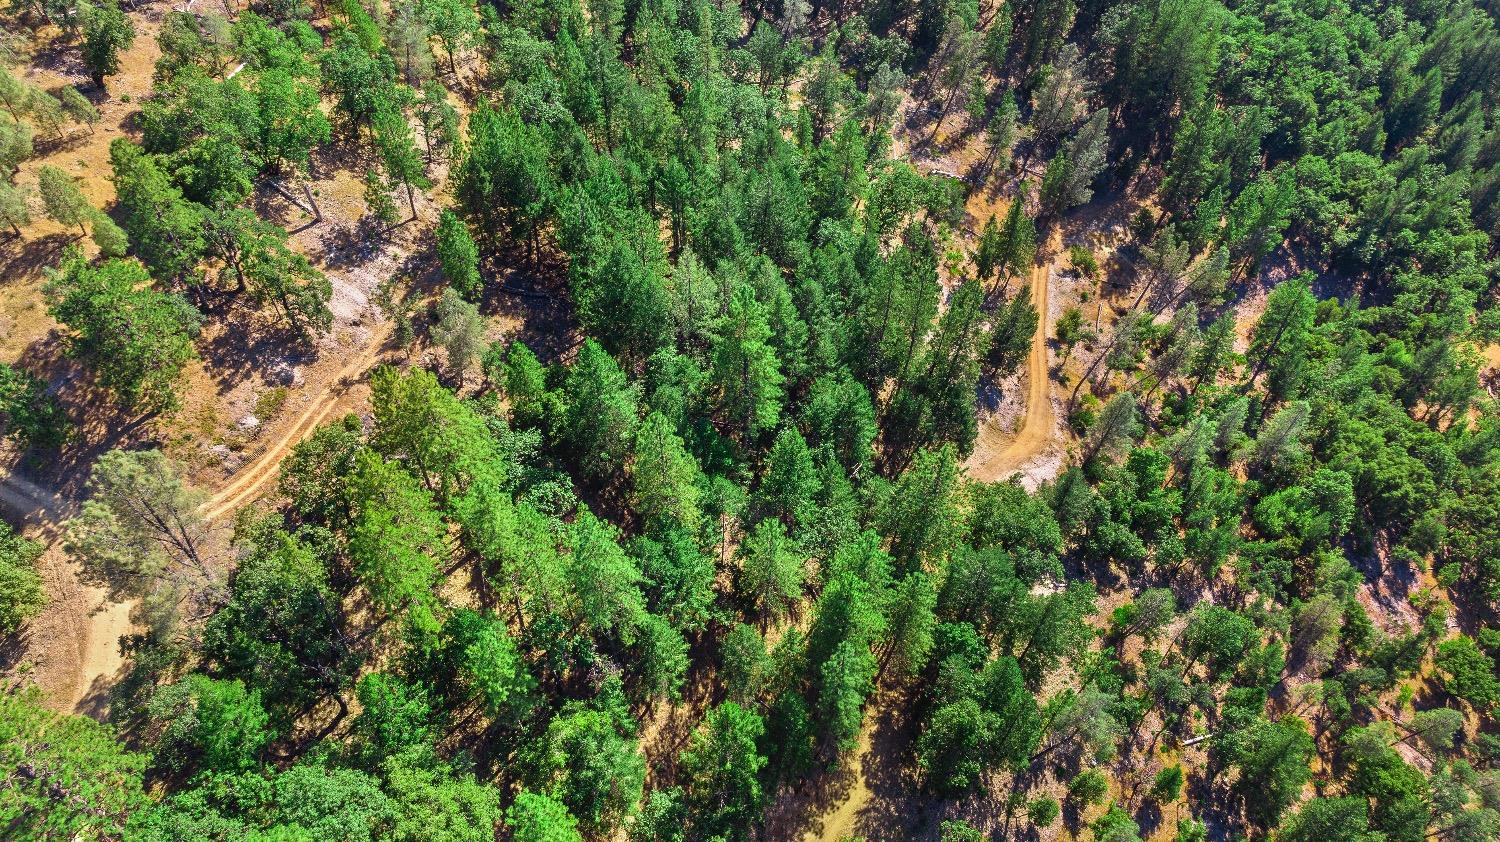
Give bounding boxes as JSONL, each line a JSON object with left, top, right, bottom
{"left": 0, "top": 2, "right": 552, "bottom": 716}
